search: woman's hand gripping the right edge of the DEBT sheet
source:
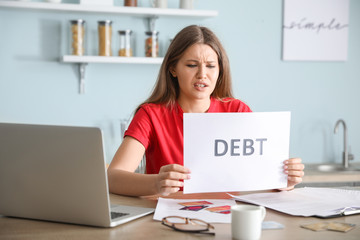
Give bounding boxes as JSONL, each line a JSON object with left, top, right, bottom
{"left": 280, "top": 158, "right": 305, "bottom": 191}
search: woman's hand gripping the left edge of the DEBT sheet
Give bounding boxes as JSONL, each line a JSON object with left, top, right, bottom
{"left": 156, "top": 164, "right": 190, "bottom": 196}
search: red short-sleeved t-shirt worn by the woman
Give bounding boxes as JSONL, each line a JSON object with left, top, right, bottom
{"left": 125, "top": 98, "right": 251, "bottom": 174}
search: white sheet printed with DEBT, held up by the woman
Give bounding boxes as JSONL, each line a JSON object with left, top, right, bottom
{"left": 184, "top": 112, "right": 291, "bottom": 193}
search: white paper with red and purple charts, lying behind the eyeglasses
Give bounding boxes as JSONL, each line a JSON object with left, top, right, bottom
{"left": 154, "top": 198, "right": 236, "bottom": 223}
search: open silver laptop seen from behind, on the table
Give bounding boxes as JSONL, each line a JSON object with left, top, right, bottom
{"left": 0, "top": 123, "right": 154, "bottom": 227}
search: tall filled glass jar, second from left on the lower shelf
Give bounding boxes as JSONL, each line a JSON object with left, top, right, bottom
{"left": 98, "top": 20, "right": 112, "bottom": 56}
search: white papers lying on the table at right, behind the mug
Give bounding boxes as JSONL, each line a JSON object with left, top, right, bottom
{"left": 229, "top": 187, "right": 360, "bottom": 218}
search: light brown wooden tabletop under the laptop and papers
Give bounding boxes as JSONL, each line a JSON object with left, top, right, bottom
{"left": 0, "top": 190, "right": 360, "bottom": 240}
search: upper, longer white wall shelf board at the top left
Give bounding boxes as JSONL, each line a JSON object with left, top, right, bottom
{"left": 0, "top": 1, "right": 218, "bottom": 18}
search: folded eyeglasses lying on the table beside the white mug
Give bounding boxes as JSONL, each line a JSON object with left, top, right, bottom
{"left": 161, "top": 216, "right": 215, "bottom": 235}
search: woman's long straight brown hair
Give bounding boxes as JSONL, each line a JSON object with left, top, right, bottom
{"left": 136, "top": 25, "right": 233, "bottom": 111}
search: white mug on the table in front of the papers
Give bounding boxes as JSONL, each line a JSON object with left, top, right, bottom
{"left": 231, "top": 205, "right": 266, "bottom": 240}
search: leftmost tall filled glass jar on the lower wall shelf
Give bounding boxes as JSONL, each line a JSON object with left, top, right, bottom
{"left": 70, "top": 19, "right": 85, "bottom": 56}
